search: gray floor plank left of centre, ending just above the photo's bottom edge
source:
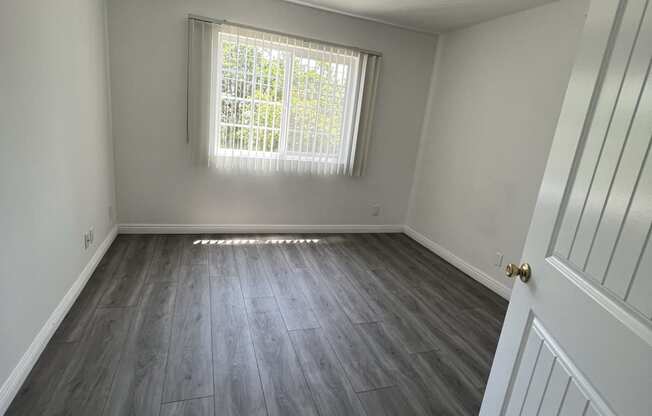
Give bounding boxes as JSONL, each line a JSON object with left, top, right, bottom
{"left": 163, "top": 260, "right": 213, "bottom": 402}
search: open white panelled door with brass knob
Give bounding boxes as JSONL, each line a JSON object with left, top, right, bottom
{"left": 480, "top": 0, "right": 652, "bottom": 416}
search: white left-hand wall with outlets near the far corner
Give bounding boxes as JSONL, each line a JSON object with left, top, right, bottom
{"left": 0, "top": 0, "right": 115, "bottom": 400}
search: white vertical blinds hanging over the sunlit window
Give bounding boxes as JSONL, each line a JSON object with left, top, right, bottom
{"left": 188, "top": 19, "right": 380, "bottom": 175}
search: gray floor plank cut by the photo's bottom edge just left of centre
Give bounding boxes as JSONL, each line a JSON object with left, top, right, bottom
{"left": 246, "top": 297, "right": 317, "bottom": 416}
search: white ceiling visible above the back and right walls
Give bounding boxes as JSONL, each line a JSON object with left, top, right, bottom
{"left": 285, "top": 0, "right": 555, "bottom": 33}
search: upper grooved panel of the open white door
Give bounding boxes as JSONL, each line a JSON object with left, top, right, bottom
{"left": 553, "top": 0, "right": 652, "bottom": 319}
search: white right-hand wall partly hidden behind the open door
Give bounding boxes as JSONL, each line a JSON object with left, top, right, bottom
{"left": 407, "top": 0, "right": 588, "bottom": 292}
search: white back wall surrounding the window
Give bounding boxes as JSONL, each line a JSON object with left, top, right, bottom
{"left": 109, "top": 0, "right": 435, "bottom": 229}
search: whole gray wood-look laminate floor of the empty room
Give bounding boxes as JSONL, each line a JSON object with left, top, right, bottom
{"left": 8, "top": 234, "right": 507, "bottom": 416}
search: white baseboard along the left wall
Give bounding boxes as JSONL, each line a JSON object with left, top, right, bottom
{"left": 0, "top": 226, "right": 118, "bottom": 415}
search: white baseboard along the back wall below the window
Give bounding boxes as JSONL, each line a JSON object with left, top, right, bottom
{"left": 118, "top": 224, "right": 403, "bottom": 234}
